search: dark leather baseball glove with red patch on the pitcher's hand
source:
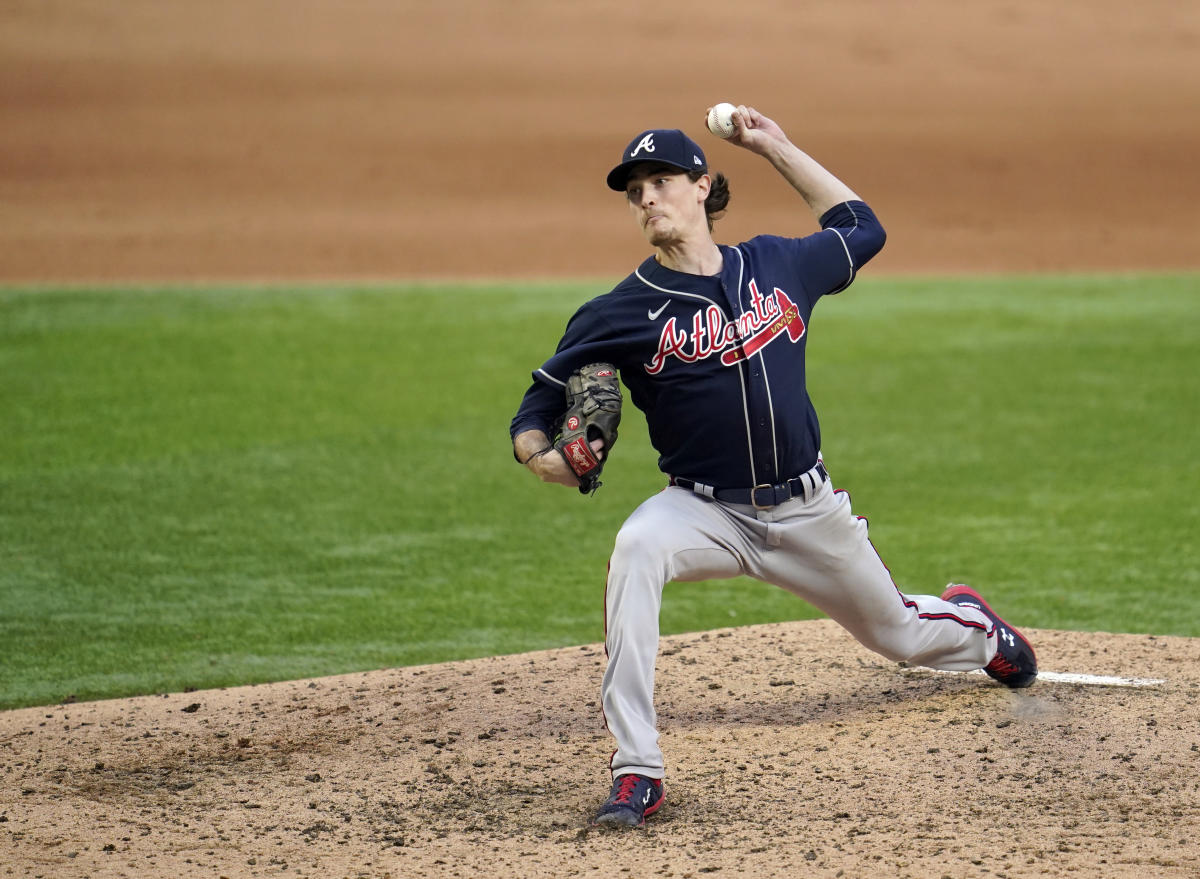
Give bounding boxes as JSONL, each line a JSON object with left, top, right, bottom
{"left": 554, "top": 363, "right": 620, "bottom": 495}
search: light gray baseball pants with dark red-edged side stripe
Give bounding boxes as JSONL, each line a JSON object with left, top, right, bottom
{"left": 601, "top": 463, "right": 996, "bottom": 778}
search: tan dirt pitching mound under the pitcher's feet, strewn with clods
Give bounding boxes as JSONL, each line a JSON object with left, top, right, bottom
{"left": 0, "top": 621, "right": 1200, "bottom": 879}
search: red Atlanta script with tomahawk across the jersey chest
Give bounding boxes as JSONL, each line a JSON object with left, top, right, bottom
{"left": 643, "top": 280, "right": 805, "bottom": 376}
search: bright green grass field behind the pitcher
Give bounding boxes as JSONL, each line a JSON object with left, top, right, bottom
{"left": 0, "top": 275, "right": 1200, "bottom": 707}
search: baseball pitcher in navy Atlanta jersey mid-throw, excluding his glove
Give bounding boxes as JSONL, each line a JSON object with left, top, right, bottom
{"left": 511, "top": 106, "right": 1037, "bottom": 826}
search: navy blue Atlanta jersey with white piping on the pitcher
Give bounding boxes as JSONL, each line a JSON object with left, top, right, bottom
{"left": 511, "top": 202, "right": 884, "bottom": 488}
